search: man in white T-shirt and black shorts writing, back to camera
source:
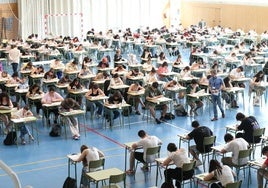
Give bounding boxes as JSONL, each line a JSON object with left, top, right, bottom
{"left": 126, "top": 130, "right": 162, "bottom": 175}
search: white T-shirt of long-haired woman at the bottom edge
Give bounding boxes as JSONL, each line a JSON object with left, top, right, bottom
{"left": 214, "top": 165, "right": 234, "bottom": 187}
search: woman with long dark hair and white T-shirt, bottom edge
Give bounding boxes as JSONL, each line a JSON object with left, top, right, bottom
{"left": 204, "top": 159, "right": 235, "bottom": 188}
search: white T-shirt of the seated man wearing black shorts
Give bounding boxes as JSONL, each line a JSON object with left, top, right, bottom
{"left": 137, "top": 136, "right": 162, "bottom": 162}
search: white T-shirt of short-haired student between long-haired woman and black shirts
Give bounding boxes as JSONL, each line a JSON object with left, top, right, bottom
{"left": 224, "top": 138, "right": 248, "bottom": 164}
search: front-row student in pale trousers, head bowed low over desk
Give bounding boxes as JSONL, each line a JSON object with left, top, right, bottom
{"left": 60, "top": 98, "right": 81, "bottom": 140}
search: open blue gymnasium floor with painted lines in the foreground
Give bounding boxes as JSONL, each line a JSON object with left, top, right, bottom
{"left": 0, "top": 47, "right": 267, "bottom": 188}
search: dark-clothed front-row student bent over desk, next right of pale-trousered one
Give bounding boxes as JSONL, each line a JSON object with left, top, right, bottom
{"left": 105, "top": 91, "right": 124, "bottom": 126}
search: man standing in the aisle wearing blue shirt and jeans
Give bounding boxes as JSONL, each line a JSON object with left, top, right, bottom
{"left": 209, "top": 69, "right": 225, "bottom": 121}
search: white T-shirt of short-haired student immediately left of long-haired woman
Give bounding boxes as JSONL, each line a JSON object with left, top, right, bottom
{"left": 169, "top": 148, "right": 190, "bottom": 168}
